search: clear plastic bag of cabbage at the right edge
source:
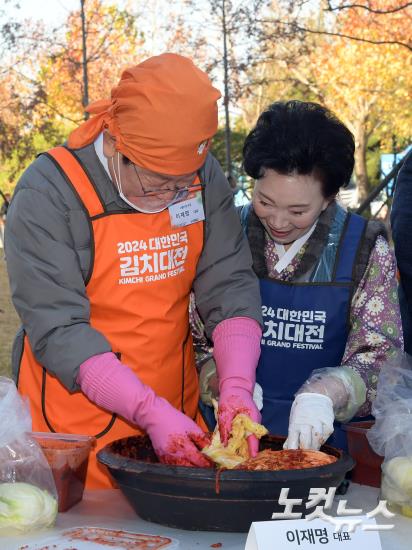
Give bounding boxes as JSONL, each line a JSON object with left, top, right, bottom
{"left": 367, "top": 352, "right": 412, "bottom": 516}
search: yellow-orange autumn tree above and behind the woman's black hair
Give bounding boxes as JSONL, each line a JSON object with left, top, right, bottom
{"left": 243, "top": 0, "right": 412, "bottom": 200}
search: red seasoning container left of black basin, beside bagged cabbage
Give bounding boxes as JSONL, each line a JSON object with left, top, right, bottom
{"left": 32, "top": 432, "right": 95, "bottom": 512}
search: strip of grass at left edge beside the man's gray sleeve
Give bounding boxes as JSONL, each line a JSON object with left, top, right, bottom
{"left": 0, "top": 256, "right": 20, "bottom": 376}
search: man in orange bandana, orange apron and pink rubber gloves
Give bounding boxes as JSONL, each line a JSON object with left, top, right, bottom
{"left": 6, "top": 54, "right": 261, "bottom": 487}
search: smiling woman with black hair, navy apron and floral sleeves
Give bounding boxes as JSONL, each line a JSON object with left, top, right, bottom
{"left": 194, "top": 101, "right": 403, "bottom": 449}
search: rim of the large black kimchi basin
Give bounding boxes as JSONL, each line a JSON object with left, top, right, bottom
{"left": 97, "top": 435, "right": 355, "bottom": 482}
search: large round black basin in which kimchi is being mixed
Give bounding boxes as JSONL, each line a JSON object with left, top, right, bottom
{"left": 97, "top": 435, "right": 354, "bottom": 532}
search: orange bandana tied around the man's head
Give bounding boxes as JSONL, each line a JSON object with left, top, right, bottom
{"left": 68, "top": 53, "right": 220, "bottom": 175}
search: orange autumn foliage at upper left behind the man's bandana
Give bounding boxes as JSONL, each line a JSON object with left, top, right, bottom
{"left": 40, "top": 0, "right": 142, "bottom": 122}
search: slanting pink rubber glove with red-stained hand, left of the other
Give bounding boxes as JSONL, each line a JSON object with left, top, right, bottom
{"left": 77, "top": 353, "right": 211, "bottom": 468}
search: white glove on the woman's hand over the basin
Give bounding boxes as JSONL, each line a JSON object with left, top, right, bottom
{"left": 283, "top": 393, "right": 335, "bottom": 450}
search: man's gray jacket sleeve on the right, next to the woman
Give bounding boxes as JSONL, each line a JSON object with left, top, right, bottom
{"left": 193, "top": 155, "right": 262, "bottom": 338}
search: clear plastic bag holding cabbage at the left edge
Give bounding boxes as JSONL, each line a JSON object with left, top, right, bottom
{"left": 0, "top": 376, "right": 57, "bottom": 535}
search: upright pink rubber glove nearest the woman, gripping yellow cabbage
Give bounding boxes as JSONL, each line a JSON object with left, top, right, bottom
{"left": 212, "top": 317, "right": 262, "bottom": 457}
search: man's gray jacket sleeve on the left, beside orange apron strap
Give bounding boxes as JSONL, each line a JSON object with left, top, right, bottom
{"left": 5, "top": 157, "right": 111, "bottom": 391}
